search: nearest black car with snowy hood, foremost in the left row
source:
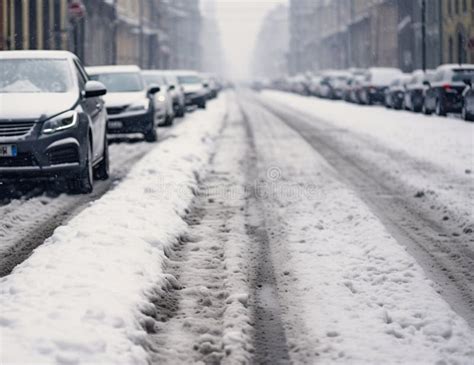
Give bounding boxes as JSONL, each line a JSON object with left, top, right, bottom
{"left": 0, "top": 51, "right": 109, "bottom": 193}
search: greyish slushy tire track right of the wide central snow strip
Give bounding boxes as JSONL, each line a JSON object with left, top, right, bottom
{"left": 254, "top": 98, "right": 474, "bottom": 326}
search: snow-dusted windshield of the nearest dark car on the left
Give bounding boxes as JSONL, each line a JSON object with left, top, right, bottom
{"left": 0, "top": 59, "right": 73, "bottom": 93}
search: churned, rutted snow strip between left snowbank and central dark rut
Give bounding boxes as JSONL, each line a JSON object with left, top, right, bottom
{"left": 149, "top": 98, "right": 253, "bottom": 364}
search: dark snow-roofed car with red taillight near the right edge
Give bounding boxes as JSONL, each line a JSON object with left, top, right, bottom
{"left": 423, "top": 65, "right": 474, "bottom": 116}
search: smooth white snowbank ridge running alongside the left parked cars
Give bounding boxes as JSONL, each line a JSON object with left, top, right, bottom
{"left": 0, "top": 98, "right": 226, "bottom": 364}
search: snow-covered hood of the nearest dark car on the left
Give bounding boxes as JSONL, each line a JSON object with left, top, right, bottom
{"left": 0, "top": 93, "right": 79, "bottom": 122}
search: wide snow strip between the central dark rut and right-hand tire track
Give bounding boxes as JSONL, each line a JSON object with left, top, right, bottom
{"left": 243, "top": 95, "right": 474, "bottom": 364}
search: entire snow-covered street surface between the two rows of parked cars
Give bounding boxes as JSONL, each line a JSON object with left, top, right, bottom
{"left": 0, "top": 89, "right": 474, "bottom": 364}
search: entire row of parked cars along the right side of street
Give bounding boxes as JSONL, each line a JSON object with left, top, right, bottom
{"left": 266, "top": 64, "right": 474, "bottom": 121}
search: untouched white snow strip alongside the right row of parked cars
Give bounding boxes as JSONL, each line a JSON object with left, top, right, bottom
{"left": 262, "top": 91, "right": 474, "bottom": 175}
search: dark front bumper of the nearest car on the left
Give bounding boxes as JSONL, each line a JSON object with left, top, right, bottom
{"left": 0, "top": 122, "right": 88, "bottom": 181}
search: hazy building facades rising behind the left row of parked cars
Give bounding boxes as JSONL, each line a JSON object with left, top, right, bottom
{"left": 0, "top": 0, "right": 206, "bottom": 69}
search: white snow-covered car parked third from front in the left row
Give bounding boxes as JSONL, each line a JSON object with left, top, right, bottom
{"left": 142, "top": 70, "right": 175, "bottom": 126}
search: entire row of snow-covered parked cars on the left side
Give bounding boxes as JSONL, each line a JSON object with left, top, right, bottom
{"left": 0, "top": 51, "right": 221, "bottom": 193}
